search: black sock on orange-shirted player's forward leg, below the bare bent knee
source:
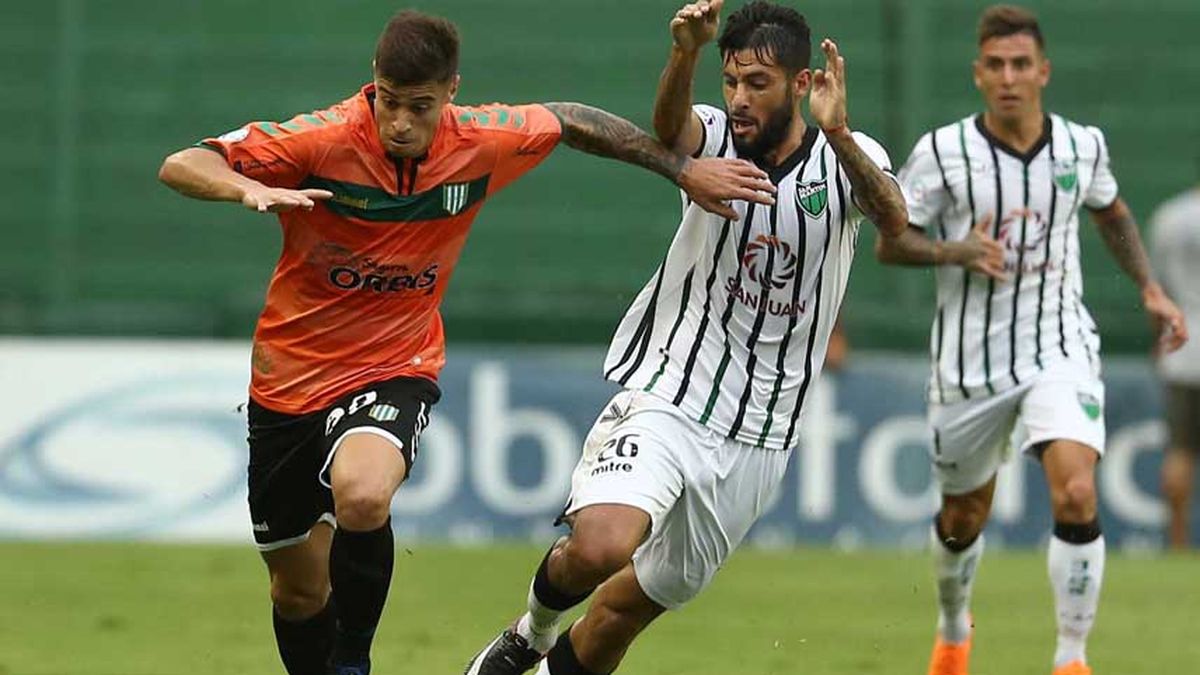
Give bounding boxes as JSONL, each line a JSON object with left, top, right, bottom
{"left": 329, "top": 518, "right": 395, "bottom": 665}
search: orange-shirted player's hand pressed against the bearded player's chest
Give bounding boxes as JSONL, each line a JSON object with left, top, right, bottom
{"left": 678, "top": 157, "right": 775, "bottom": 220}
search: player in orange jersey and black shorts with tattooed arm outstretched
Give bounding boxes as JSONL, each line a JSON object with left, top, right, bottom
{"left": 160, "top": 11, "right": 774, "bottom": 675}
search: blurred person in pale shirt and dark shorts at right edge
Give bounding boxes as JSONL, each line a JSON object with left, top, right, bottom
{"left": 1150, "top": 177, "right": 1200, "bottom": 549}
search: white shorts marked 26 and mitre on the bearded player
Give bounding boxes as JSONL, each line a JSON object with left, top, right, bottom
{"left": 564, "top": 389, "right": 791, "bottom": 609}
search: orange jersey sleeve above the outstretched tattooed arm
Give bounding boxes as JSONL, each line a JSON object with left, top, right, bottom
{"left": 469, "top": 103, "right": 563, "bottom": 193}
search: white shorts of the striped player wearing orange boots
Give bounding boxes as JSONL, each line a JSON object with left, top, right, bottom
{"left": 929, "top": 362, "right": 1104, "bottom": 495}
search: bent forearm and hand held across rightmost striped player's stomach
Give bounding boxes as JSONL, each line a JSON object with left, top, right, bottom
{"left": 875, "top": 215, "right": 1008, "bottom": 281}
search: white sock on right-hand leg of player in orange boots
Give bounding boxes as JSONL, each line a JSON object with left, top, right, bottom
{"left": 1046, "top": 536, "right": 1104, "bottom": 668}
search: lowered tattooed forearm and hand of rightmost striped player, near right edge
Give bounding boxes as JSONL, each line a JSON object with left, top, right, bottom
{"left": 1091, "top": 197, "right": 1188, "bottom": 352}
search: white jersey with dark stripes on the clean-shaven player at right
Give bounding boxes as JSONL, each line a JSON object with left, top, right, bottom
{"left": 900, "top": 115, "right": 1117, "bottom": 402}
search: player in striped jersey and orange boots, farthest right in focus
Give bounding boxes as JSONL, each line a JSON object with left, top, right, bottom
{"left": 877, "top": 6, "right": 1187, "bottom": 675}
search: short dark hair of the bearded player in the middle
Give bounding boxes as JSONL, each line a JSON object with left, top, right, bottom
{"left": 716, "top": 0, "right": 812, "bottom": 72}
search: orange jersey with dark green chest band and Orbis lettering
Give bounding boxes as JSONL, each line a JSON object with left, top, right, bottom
{"left": 202, "top": 84, "right": 562, "bottom": 414}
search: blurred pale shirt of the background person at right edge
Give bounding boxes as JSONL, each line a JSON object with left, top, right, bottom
{"left": 1150, "top": 189, "right": 1200, "bottom": 387}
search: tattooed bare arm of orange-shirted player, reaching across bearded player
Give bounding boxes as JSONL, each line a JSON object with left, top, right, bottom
{"left": 544, "top": 103, "right": 775, "bottom": 220}
